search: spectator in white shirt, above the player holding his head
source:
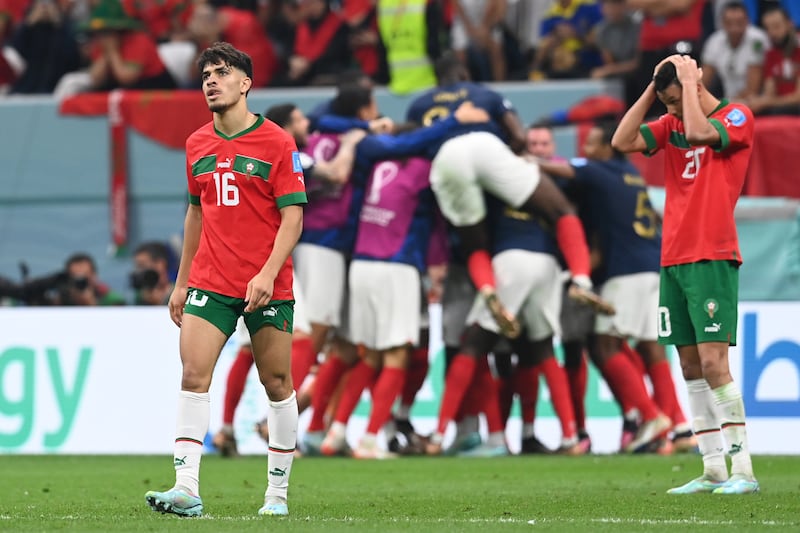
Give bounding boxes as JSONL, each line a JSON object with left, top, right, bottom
{"left": 703, "top": 1, "right": 768, "bottom": 99}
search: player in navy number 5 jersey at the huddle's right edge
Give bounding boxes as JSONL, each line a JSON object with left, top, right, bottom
{"left": 540, "top": 121, "right": 691, "bottom": 451}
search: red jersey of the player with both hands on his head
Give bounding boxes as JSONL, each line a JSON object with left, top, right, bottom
{"left": 641, "top": 100, "right": 754, "bottom": 266}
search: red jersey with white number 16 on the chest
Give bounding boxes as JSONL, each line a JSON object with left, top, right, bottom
{"left": 186, "top": 116, "right": 307, "bottom": 300}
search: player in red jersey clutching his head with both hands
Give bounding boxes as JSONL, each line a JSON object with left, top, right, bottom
{"left": 612, "top": 55, "right": 759, "bottom": 494}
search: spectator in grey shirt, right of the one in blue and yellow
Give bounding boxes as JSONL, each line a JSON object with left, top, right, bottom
{"left": 591, "top": 0, "right": 641, "bottom": 78}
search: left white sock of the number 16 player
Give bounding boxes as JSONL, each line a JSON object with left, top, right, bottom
{"left": 173, "top": 390, "right": 211, "bottom": 496}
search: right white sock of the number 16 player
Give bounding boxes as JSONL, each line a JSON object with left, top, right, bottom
{"left": 264, "top": 391, "right": 298, "bottom": 503}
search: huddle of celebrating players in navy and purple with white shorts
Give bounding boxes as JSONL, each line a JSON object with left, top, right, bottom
{"left": 214, "top": 54, "right": 696, "bottom": 458}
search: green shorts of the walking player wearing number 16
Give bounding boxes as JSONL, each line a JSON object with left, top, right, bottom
{"left": 183, "top": 287, "right": 294, "bottom": 337}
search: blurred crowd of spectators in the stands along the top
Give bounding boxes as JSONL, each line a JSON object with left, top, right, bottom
{"left": 0, "top": 0, "right": 800, "bottom": 106}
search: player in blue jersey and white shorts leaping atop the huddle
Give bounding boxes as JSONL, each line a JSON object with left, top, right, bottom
{"left": 407, "top": 55, "right": 613, "bottom": 337}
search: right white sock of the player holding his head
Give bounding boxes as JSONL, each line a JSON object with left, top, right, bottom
{"left": 711, "top": 381, "right": 753, "bottom": 478}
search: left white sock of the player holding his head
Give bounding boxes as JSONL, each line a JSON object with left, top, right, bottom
{"left": 686, "top": 379, "right": 728, "bottom": 481}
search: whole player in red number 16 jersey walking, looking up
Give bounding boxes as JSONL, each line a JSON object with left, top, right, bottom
{"left": 145, "top": 43, "right": 306, "bottom": 516}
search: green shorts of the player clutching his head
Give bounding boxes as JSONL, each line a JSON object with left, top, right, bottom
{"left": 658, "top": 261, "right": 739, "bottom": 346}
